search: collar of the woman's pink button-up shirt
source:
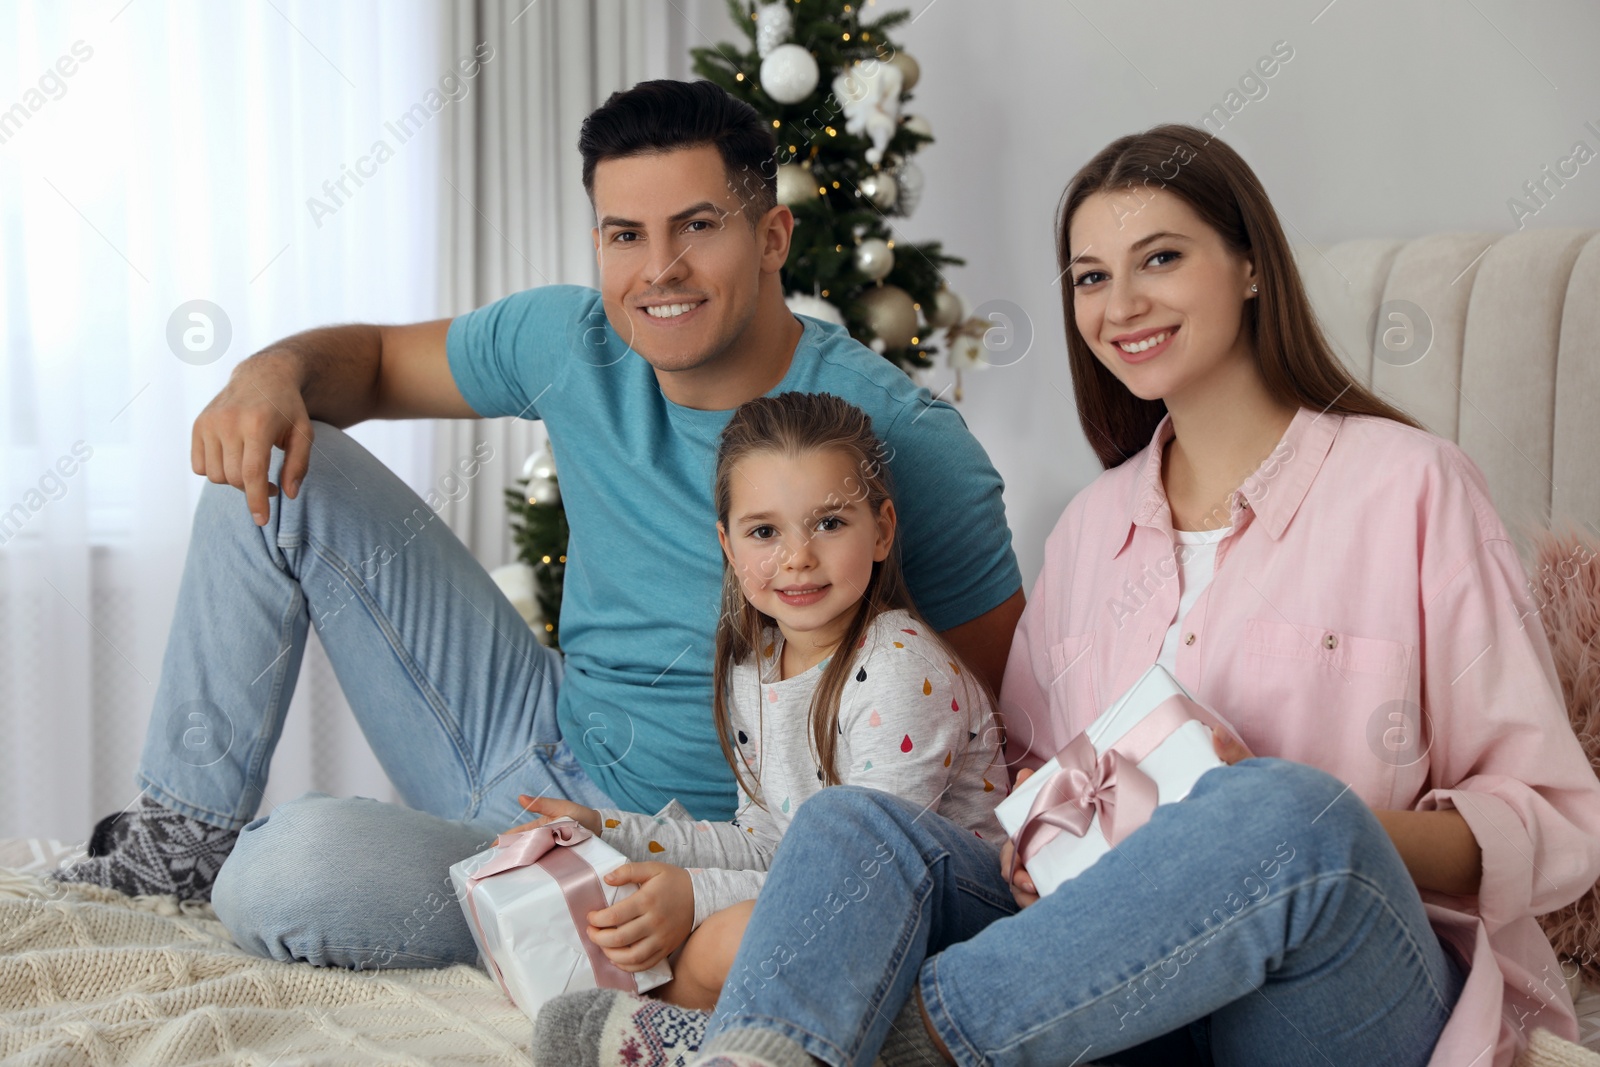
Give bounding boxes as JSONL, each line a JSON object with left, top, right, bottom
{"left": 1112, "top": 408, "right": 1344, "bottom": 558}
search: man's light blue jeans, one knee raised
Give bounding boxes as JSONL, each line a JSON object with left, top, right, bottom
{"left": 136, "top": 422, "right": 610, "bottom": 968}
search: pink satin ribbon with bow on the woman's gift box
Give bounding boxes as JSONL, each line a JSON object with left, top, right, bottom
{"left": 1013, "top": 694, "right": 1232, "bottom": 867}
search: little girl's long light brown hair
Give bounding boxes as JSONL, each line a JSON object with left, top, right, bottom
{"left": 712, "top": 392, "right": 994, "bottom": 806}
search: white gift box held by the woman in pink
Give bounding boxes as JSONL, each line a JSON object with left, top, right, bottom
{"left": 995, "top": 664, "right": 1235, "bottom": 894}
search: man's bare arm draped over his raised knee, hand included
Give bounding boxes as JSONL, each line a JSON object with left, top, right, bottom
{"left": 189, "top": 318, "right": 478, "bottom": 526}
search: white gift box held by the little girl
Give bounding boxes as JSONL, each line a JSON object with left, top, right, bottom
{"left": 450, "top": 819, "right": 672, "bottom": 1019}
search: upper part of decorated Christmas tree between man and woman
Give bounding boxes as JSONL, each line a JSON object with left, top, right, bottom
{"left": 690, "top": 0, "right": 989, "bottom": 370}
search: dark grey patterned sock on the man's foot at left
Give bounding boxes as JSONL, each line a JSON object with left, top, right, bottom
{"left": 50, "top": 795, "right": 238, "bottom": 901}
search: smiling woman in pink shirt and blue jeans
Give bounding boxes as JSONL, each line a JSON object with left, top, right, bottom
{"left": 537, "top": 126, "right": 1600, "bottom": 1067}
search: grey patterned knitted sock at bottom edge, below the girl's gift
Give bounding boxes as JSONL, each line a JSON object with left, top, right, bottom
{"left": 533, "top": 989, "right": 710, "bottom": 1067}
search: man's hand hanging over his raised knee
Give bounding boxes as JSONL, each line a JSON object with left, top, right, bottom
{"left": 189, "top": 358, "right": 312, "bottom": 526}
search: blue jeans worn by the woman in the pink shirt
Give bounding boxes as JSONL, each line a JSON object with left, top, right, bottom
{"left": 707, "top": 758, "right": 1464, "bottom": 1067}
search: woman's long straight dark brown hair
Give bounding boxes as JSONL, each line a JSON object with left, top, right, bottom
{"left": 1056, "top": 123, "right": 1422, "bottom": 469}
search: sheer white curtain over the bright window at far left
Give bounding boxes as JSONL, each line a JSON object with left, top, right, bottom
{"left": 0, "top": 0, "right": 470, "bottom": 841}
